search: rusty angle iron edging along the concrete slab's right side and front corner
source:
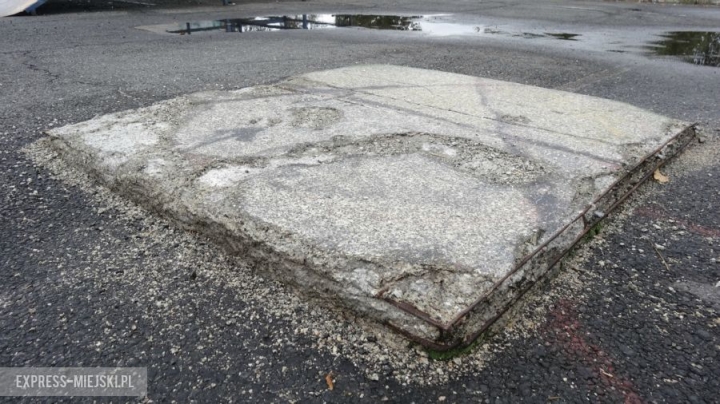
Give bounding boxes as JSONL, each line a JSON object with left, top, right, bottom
{"left": 380, "top": 124, "right": 697, "bottom": 351}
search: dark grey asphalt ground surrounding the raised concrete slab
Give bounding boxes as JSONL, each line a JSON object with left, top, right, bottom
{"left": 0, "top": 1, "right": 720, "bottom": 403}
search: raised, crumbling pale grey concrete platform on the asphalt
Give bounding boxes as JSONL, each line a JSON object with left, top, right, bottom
{"left": 43, "top": 66, "right": 694, "bottom": 349}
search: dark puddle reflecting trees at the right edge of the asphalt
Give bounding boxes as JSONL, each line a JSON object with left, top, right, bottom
{"left": 648, "top": 31, "right": 720, "bottom": 67}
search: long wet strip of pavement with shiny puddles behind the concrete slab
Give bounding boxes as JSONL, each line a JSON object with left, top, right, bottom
{"left": 137, "top": 9, "right": 720, "bottom": 67}
